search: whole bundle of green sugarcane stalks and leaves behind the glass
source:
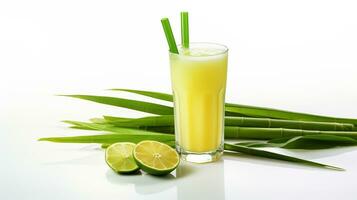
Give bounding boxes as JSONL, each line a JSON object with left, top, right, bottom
{"left": 40, "top": 89, "right": 357, "bottom": 169}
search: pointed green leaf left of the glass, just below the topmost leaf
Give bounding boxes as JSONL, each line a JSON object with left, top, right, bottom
{"left": 61, "top": 95, "right": 173, "bottom": 115}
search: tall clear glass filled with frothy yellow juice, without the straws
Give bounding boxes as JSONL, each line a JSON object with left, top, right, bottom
{"left": 170, "top": 43, "right": 228, "bottom": 163}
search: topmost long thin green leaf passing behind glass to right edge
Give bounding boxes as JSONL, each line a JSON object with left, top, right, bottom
{"left": 110, "top": 89, "right": 357, "bottom": 125}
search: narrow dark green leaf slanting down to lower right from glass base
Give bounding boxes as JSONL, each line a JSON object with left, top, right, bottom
{"left": 224, "top": 143, "right": 344, "bottom": 171}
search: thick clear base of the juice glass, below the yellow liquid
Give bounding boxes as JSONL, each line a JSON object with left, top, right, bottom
{"left": 176, "top": 145, "right": 223, "bottom": 163}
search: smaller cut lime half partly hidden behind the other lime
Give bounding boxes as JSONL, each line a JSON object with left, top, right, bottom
{"left": 105, "top": 142, "right": 139, "bottom": 173}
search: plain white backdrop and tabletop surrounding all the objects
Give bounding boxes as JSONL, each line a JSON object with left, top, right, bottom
{"left": 0, "top": 0, "right": 357, "bottom": 200}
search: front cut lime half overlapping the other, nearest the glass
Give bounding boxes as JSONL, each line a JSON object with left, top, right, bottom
{"left": 133, "top": 140, "right": 180, "bottom": 176}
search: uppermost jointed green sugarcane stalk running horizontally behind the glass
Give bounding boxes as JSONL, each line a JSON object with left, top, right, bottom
{"left": 104, "top": 115, "right": 354, "bottom": 131}
